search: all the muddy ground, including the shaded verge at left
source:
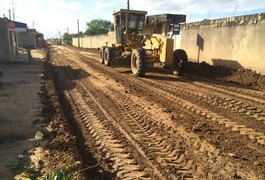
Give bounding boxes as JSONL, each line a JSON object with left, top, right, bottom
{"left": 0, "top": 46, "right": 265, "bottom": 179}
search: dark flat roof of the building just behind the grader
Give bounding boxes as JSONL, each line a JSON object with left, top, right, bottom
{"left": 146, "top": 14, "right": 186, "bottom": 25}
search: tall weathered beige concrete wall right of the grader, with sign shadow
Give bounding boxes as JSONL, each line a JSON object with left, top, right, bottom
{"left": 181, "top": 13, "right": 265, "bottom": 74}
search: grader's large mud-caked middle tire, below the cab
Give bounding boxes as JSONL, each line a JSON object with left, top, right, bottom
{"left": 131, "top": 48, "right": 145, "bottom": 77}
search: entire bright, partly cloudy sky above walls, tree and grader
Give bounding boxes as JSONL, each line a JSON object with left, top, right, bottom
{"left": 0, "top": 0, "right": 265, "bottom": 38}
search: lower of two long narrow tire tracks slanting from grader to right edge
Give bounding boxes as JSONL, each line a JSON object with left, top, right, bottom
{"left": 51, "top": 46, "right": 260, "bottom": 177}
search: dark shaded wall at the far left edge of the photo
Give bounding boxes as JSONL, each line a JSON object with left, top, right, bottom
{"left": 0, "top": 18, "right": 11, "bottom": 62}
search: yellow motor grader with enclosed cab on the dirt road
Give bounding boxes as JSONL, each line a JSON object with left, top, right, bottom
{"left": 100, "top": 9, "right": 188, "bottom": 77}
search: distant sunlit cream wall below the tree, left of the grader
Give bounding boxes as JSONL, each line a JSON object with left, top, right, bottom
{"left": 72, "top": 32, "right": 115, "bottom": 48}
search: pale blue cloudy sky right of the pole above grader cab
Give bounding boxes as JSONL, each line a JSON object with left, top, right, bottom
{"left": 131, "top": 0, "right": 265, "bottom": 21}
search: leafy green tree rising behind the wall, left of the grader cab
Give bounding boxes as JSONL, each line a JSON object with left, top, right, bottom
{"left": 85, "top": 19, "right": 112, "bottom": 35}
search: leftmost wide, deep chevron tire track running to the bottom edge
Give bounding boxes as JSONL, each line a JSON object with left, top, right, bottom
{"left": 65, "top": 92, "right": 154, "bottom": 179}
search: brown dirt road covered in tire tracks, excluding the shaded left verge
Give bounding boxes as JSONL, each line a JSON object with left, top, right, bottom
{"left": 47, "top": 46, "right": 265, "bottom": 179}
